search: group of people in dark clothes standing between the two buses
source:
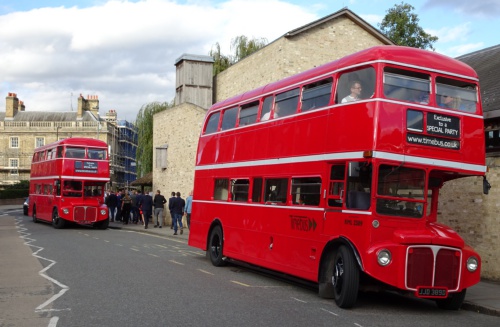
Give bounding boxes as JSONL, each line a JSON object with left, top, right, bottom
{"left": 105, "top": 189, "right": 193, "bottom": 235}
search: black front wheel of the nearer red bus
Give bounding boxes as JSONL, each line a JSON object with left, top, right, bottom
{"left": 332, "top": 245, "right": 359, "bottom": 308}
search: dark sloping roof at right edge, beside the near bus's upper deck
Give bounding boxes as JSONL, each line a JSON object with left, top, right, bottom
{"left": 456, "top": 44, "right": 500, "bottom": 118}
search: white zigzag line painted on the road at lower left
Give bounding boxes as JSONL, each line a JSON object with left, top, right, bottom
{"left": 16, "top": 218, "right": 71, "bottom": 327}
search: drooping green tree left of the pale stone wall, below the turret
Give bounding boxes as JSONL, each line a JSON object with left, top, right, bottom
{"left": 135, "top": 100, "right": 174, "bottom": 177}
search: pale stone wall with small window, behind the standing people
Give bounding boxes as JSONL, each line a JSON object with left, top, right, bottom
{"left": 153, "top": 103, "right": 206, "bottom": 223}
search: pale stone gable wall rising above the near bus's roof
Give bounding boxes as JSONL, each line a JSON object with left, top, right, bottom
{"left": 215, "top": 16, "right": 382, "bottom": 102}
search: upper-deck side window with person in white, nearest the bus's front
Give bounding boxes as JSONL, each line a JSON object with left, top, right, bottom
{"left": 335, "top": 67, "right": 376, "bottom": 103}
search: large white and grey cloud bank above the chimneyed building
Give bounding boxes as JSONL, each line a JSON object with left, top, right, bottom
{"left": 0, "top": 0, "right": 318, "bottom": 120}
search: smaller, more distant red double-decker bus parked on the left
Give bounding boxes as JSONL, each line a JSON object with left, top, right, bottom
{"left": 28, "top": 138, "right": 109, "bottom": 229}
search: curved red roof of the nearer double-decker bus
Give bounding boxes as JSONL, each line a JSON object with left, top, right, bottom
{"left": 209, "top": 45, "right": 478, "bottom": 111}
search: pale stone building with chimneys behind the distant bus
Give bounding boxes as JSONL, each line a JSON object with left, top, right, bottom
{"left": 0, "top": 93, "right": 137, "bottom": 187}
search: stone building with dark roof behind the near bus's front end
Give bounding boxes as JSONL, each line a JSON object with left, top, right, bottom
{"left": 439, "top": 45, "right": 500, "bottom": 281}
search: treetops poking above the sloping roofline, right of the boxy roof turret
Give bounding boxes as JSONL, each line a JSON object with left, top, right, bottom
{"left": 208, "top": 35, "right": 267, "bottom": 76}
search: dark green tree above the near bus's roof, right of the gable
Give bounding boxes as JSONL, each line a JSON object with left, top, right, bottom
{"left": 378, "top": 2, "right": 438, "bottom": 50}
